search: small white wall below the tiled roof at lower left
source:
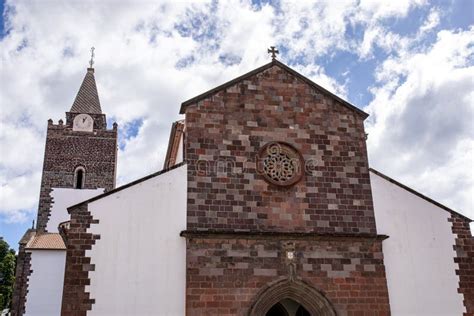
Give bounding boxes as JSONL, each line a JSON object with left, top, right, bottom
{"left": 25, "top": 250, "right": 66, "bottom": 316}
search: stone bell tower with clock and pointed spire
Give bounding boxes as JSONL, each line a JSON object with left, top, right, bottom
{"left": 36, "top": 67, "right": 117, "bottom": 232}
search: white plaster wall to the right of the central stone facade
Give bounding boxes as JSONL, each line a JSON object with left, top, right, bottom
{"left": 370, "top": 172, "right": 465, "bottom": 316}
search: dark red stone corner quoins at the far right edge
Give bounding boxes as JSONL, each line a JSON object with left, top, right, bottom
{"left": 449, "top": 213, "right": 474, "bottom": 316}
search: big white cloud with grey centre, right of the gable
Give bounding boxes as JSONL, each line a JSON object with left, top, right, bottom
{"left": 367, "top": 28, "right": 474, "bottom": 218}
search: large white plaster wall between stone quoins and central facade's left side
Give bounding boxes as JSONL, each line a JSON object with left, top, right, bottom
{"left": 86, "top": 166, "right": 187, "bottom": 316}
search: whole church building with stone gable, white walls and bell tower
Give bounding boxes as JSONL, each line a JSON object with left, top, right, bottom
{"left": 9, "top": 59, "right": 474, "bottom": 316}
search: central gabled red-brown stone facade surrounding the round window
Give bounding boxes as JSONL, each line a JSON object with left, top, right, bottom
{"left": 181, "top": 61, "right": 390, "bottom": 316}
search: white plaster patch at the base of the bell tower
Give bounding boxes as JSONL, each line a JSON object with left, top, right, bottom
{"left": 46, "top": 188, "right": 104, "bottom": 233}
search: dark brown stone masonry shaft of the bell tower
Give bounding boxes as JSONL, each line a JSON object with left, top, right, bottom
{"left": 37, "top": 116, "right": 117, "bottom": 231}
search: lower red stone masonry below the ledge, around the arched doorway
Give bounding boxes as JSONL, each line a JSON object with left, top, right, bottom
{"left": 186, "top": 234, "right": 390, "bottom": 316}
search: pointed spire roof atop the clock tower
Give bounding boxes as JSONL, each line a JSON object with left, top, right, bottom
{"left": 69, "top": 68, "right": 102, "bottom": 114}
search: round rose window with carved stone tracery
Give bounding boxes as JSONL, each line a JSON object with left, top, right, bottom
{"left": 259, "top": 142, "right": 303, "bottom": 186}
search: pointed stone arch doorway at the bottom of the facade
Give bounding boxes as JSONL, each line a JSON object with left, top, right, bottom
{"left": 249, "top": 279, "right": 337, "bottom": 316}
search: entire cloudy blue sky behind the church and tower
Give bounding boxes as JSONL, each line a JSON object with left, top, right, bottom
{"left": 0, "top": 0, "right": 474, "bottom": 251}
